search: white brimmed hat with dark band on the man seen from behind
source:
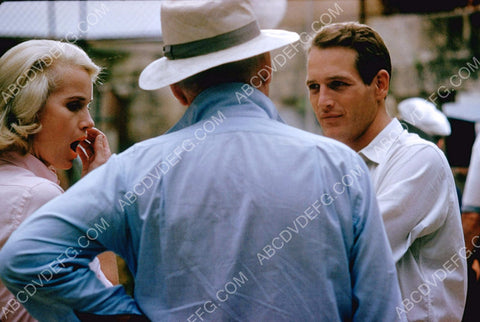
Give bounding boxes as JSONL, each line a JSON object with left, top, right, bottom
{"left": 139, "top": 0, "right": 299, "bottom": 90}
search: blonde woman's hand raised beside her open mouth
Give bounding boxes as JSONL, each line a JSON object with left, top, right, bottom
{"left": 77, "top": 128, "right": 112, "bottom": 177}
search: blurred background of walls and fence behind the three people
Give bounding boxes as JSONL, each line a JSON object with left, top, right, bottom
{"left": 0, "top": 0, "right": 480, "bottom": 296}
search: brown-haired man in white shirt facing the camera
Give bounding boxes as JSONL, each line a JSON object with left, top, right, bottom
{"left": 306, "top": 23, "right": 467, "bottom": 321}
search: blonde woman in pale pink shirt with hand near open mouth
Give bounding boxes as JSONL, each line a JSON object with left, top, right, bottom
{"left": 0, "top": 40, "right": 114, "bottom": 321}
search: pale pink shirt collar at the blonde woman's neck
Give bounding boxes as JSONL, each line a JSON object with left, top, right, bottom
{"left": 0, "top": 152, "right": 59, "bottom": 184}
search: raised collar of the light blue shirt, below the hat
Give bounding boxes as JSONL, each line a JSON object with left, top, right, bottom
{"left": 167, "top": 83, "right": 284, "bottom": 133}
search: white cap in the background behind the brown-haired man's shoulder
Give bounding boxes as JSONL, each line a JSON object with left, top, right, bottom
{"left": 398, "top": 97, "right": 452, "bottom": 136}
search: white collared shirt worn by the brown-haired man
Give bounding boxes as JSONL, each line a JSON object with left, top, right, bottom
{"left": 359, "top": 119, "right": 467, "bottom": 321}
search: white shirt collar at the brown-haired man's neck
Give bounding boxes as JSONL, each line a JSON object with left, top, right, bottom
{"left": 359, "top": 118, "right": 404, "bottom": 164}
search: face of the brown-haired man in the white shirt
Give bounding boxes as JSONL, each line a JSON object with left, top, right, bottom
{"left": 306, "top": 47, "right": 388, "bottom": 151}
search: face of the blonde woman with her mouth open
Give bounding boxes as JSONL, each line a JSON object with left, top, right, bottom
{"left": 32, "top": 67, "right": 94, "bottom": 169}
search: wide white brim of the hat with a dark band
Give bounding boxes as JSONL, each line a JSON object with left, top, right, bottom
{"left": 138, "top": 29, "right": 300, "bottom": 90}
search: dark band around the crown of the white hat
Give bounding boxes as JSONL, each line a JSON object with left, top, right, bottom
{"left": 163, "top": 21, "right": 260, "bottom": 60}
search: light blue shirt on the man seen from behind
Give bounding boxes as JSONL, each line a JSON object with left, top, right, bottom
{"left": 0, "top": 83, "right": 401, "bottom": 322}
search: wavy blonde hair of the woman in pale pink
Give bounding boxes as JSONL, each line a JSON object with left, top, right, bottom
{"left": 0, "top": 40, "right": 101, "bottom": 154}
